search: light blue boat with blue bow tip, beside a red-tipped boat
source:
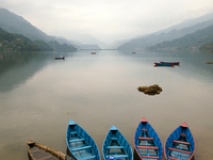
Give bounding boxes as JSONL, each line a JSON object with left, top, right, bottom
{"left": 102, "top": 126, "right": 133, "bottom": 160}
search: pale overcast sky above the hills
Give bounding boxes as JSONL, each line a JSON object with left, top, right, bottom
{"left": 0, "top": 0, "right": 213, "bottom": 43}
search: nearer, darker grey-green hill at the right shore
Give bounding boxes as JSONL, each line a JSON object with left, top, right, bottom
{"left": 150, "top": 25, "right": 213, "bottom": 50}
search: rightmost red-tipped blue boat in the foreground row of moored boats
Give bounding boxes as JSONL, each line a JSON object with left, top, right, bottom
{"left": 164, "top": 122, "right": 195, "bottom": 160}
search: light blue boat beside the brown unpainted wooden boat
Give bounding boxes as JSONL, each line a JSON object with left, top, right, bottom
{"left": 66, "top": 120, "right": 101, "bottom": 160}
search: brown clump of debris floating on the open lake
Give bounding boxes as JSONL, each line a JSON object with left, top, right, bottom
{"left": 138, "top": 84, "right": 162, "bottom": 95}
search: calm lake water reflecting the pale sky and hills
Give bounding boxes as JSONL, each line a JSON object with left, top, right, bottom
{"left": 0, "top": 50, "right": 213, "bottom": 160}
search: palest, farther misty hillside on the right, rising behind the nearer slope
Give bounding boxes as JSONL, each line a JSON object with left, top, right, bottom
{"left": 118, "top": 13, "right": 213, "bottom": 50}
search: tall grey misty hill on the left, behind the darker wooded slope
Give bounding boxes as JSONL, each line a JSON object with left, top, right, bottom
{"left": 0, "top": 8, "right": 76, "bottom": 51}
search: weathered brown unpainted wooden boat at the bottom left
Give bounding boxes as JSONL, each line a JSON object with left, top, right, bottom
{"left": 27, "top": 140, "right": 71, "bottom": 160}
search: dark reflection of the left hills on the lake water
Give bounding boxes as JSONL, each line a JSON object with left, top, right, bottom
{"left": 0, "top": 52, "right": 76, "bottom": 93}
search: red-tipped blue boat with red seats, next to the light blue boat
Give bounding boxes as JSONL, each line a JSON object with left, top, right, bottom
{"left": 133, "top": 117, "right": 163, "bottom": 160}
